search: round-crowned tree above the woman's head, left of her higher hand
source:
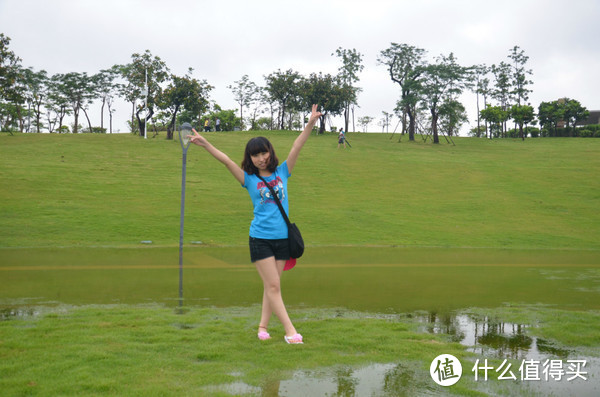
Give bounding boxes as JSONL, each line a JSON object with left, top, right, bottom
{"left": 265, "top": 69, "right": 302, "bottom": 130}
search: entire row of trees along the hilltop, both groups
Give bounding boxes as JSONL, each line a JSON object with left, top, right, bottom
{"left": 0, "top": 33, "right": 589, "bottom": 143}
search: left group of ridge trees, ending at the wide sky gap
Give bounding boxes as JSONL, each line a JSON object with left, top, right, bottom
{"left": 0, "top": 33, "right": 362, "bottom": 139}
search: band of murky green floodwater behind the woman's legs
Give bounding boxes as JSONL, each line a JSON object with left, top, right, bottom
{"left": 0, "top": 247, "right": 600, "bottom": 313}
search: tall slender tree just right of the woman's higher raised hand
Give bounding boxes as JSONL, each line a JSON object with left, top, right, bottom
{"left": 331, "top": 47, "right": 364, "bottom": 131}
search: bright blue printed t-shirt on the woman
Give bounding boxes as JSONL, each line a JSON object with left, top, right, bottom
{"left": 242, "top": 161, "right": 291, "bottom": 240}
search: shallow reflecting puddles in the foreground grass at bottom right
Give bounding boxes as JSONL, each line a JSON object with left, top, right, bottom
{"left": 207, "top": 313, "right": 600, "bottom": 397}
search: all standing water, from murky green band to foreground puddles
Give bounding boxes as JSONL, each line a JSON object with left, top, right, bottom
{"left": 0, "top": 247, "right": 600, "bottom": 396}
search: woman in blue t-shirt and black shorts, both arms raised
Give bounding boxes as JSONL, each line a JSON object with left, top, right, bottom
{"left": 190, "top": 105, "right": 321, "bottom": 344}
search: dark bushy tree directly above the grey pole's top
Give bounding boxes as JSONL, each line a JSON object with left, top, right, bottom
{"left": 156, "top": 68, "right": 214, "bottom": 139}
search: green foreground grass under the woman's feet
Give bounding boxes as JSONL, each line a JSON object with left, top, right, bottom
{"left": 0, "top": 305, "right": 463, "bottom": 395}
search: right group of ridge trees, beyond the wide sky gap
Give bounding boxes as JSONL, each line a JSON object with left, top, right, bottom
{"left": 378, "top": 43, "right": 600, "bottom": 143}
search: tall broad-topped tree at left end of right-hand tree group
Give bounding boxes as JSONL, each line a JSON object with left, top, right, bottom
{"left": 377, "top": 43, "right": 425, "bottom": 141}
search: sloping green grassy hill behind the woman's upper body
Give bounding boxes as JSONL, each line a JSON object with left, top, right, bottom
{"left": 0, "top": 131, "right": 600, "bottom": 249}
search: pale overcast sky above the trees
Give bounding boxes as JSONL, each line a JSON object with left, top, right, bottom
{"left": 0, "top": 0, "right": 600, "bottom": 135}
